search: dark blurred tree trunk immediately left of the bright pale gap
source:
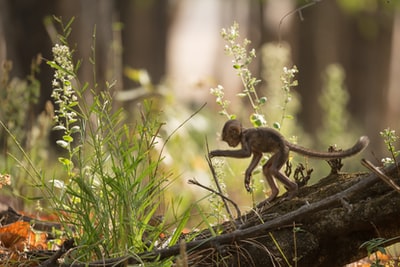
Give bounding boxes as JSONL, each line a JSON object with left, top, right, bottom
{"left": 117, "top": 0, "right": 168, "bottom": 88}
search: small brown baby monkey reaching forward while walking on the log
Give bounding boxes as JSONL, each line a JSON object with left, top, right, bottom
{"left": 209, "top": 120, "right": 369, "bottom": 202}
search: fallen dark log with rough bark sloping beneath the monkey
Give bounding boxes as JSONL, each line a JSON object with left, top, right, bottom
{"left": 1, "top": 160, "right": 400, "bottom": 267}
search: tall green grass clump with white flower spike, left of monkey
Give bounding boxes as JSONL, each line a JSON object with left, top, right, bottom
{"left": 42, "top": 21, "right": 173, "bottom": 261}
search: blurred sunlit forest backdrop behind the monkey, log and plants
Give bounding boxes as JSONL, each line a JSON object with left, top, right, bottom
{"left": 0, "top": 0, "right": 400, "bottom": 266}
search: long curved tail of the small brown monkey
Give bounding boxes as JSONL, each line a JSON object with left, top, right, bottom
{"left": 287, "top": 136, "right": 369, "bottom": 159}
